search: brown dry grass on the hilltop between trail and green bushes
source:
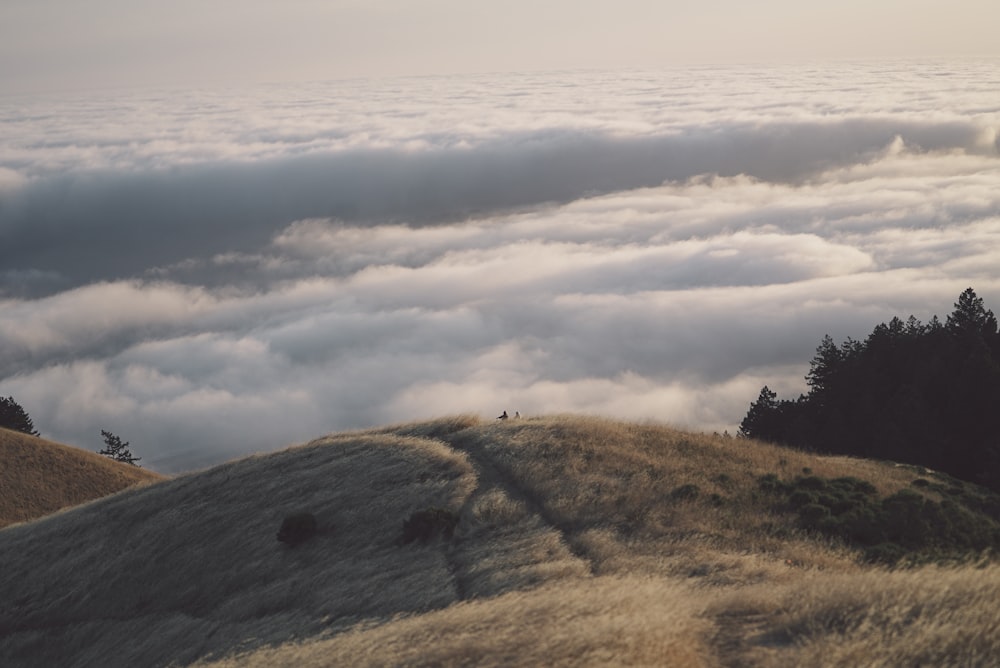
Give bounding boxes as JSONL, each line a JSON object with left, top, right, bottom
{"left": 451, "top": 416, "right": 900, "bottom": 584}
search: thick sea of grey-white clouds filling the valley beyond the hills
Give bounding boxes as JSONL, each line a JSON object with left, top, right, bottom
{"left": 0, "top": 60, "right": 1000, "bottom": 472}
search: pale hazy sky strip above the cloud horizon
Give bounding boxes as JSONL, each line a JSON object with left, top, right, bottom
{"left": 0, "top": 0, "right": 1000, "bottom": 92}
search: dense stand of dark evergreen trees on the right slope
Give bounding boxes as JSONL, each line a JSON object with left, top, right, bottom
{"left": 739, "top": 288, "right": 1000, "bottom": 490}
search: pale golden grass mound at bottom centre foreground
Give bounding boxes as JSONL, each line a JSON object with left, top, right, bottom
{"left": 208, "top": 578, "right": 712, "bottom": 668}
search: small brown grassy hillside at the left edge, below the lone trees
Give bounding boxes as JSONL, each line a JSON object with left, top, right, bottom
{"left": 0, "top": 427, "right": 162, "bottom": 527}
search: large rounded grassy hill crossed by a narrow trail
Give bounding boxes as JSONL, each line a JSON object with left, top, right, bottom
{"left": 0, "top": 416, "right": 1000, "bottom": 666}
